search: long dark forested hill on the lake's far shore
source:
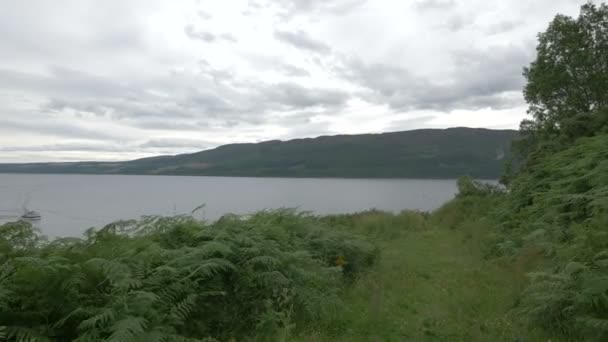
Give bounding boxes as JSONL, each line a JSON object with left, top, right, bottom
{"left": 0, "top": 128, "right": 518, "bottom": 179}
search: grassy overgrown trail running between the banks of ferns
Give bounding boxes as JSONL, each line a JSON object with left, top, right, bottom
{"left": 305, "top": 214, "right": 547, "bottom": 341}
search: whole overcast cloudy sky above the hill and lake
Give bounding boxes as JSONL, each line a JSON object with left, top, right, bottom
{"left": 0, "top": 0, "right": 584, "bottom": 162}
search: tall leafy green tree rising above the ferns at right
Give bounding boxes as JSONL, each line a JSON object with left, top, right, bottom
{"left": 521, "top": 2, "right": 608, "bottom": 139}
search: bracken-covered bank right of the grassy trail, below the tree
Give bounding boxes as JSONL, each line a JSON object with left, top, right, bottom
{"left": 480, "top": 134, "right": 608, "bottom": 341}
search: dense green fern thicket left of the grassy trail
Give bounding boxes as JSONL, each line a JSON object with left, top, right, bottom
{"left": 0, "top": 210, "right": 376, "bottom": 341}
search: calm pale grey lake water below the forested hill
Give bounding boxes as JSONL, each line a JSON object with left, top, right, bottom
{"left": 0, "top": 174, "right": 457, "bottom": 237}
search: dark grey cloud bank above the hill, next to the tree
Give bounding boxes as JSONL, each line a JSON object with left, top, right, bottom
{"left": 342, "top": 46, "right": 532, "bottom": 111}
